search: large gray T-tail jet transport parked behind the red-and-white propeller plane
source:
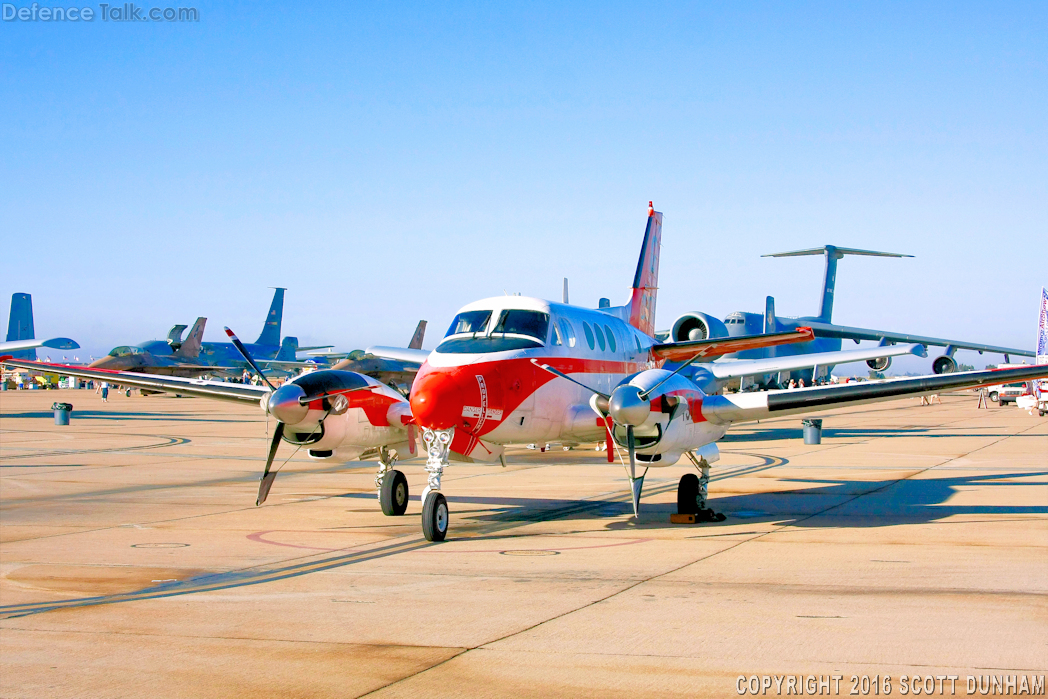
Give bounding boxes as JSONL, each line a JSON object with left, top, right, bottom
{"left": 659, "top": 245, "right": 1033, "bottom": 383}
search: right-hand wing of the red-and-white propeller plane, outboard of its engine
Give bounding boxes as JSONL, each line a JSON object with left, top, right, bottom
{"left": 702, "top": 364, "right": 1048, "bottom": 424}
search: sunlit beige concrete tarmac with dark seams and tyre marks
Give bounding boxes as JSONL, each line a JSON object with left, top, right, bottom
{"left": 0, "top": 391, "right": 1048, "bottom": 698}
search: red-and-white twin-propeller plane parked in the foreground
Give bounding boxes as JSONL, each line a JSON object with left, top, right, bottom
{"left": 5, "top": 206, "right": 1048, "bottom": 541}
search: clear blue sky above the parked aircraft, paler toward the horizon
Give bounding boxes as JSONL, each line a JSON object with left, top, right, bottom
{"left": 0, "top": 2, "right": 1048, "bottom": 369}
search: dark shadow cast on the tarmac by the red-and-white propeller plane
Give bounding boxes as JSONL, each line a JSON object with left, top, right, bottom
{"left": 342, "top": 472, "right": 1048, "bottom": 530}
